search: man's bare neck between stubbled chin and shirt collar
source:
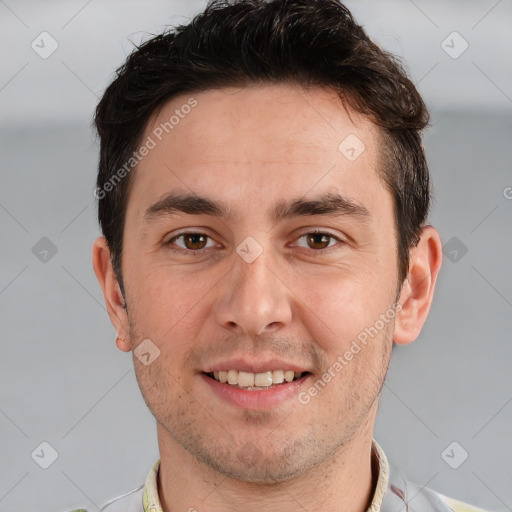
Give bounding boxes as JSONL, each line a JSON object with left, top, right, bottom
{"left": 157, "top": 412, "right": 378, "bottom": 512}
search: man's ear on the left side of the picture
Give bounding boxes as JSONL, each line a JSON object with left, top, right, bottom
{"left": 92, "top": 236, "right": 131, "bottom": 352}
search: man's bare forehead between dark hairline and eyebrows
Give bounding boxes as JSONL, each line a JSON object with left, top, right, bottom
{"left": 127, "top": 84, "right": 389, "bottom": 224}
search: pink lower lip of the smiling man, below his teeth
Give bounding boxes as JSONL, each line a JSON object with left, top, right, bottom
{"left": 201, "top": 373, "right": 311, "bottom": 410}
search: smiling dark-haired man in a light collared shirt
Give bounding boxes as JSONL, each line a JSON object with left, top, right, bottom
{"left": 93, "top": 0, "right": 490, "bottom": 512}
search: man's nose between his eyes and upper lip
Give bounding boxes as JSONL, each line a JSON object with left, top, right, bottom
{"left": 214, "top": 240, "right": 293, "bottom": 336}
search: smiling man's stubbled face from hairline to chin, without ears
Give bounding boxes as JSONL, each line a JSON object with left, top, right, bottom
{"left": 117, "top": 85, "right": 398, "bottom": 482}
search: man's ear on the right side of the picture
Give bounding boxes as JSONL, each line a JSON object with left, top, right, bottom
{"left": 393, "top": 226, "right": 443, "bottom": 345}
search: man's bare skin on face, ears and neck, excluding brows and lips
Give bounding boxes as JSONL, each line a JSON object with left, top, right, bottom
{"left": 93, "top": 85, "right": 442, "bottom": 512}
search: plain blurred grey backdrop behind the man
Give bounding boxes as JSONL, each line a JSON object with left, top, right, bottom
{"left": 0, "top": 0, "right": 512, "bottom": 512}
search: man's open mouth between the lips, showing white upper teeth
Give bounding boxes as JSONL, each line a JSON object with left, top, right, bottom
{"left": 203, "top": 370, "right": 310, "bottom": 391}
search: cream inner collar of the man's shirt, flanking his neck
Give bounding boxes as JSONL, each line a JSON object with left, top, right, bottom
{"left": 142, "top": 439, "right": 389, "bottom": 512}
